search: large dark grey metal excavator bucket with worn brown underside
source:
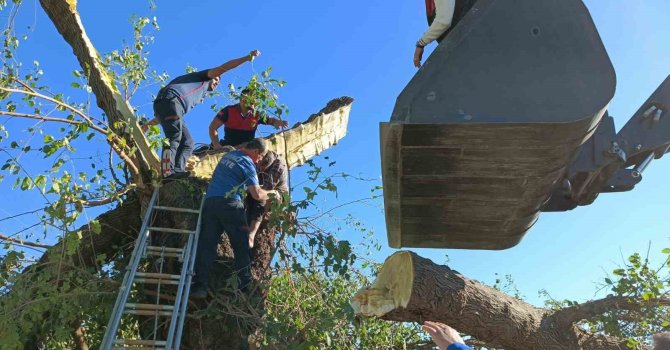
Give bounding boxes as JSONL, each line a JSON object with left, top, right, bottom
{"left": 380, "top": 0, "right": 616, "bottom": 249}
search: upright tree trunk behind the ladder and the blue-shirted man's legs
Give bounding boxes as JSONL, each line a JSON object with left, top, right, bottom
{"left": 144, "top": 179, "right": 275, "bottom": 349}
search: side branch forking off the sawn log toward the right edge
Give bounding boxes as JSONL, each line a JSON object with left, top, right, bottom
{"left": 553, "top": 296, "right": 670, "bottom": 325}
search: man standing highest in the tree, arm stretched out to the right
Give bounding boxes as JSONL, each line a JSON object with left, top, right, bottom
{"left": 142, "top": 50, "right": 260, "bottom": 178}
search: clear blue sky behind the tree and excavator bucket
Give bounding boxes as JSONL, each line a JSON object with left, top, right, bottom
{"left": 0, "top": 0, "right": 670, "bottom": 303}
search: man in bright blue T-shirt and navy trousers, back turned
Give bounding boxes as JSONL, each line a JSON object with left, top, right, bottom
{"left": 191, "top": 139, "right": 277, "bottom": 299}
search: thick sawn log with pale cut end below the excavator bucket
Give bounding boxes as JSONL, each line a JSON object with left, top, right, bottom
{"left": 352, "top": 251, "right": 644, "bottom": 350}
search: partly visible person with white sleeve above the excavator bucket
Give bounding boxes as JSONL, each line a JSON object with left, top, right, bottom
{"left": 414, "top": 0, "right": 477, "bottom": 68}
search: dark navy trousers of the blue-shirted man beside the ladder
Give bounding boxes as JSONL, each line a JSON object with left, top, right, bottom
{"left": 194, "top": 197, "right": 251, "bottom": 292}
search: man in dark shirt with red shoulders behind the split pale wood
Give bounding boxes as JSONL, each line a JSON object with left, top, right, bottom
{"left": 209, "top": 89, "right": 288, "bottom": 150}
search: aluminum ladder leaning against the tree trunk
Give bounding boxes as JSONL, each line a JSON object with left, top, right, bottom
{"left": 100, "top": 186, "right": 205, "bottom": 350}
